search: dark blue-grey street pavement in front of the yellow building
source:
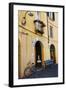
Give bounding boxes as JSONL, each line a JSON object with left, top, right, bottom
{"left": 25, "top": 64, "right": 58, "bottom": 79}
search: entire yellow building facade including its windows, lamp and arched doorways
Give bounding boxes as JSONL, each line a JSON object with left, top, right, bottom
{"left": 18, "top": 10, "right": 58, "bottom": 78}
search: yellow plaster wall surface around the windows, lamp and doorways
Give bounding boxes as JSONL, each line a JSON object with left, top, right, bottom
{"left": 18, "top": 11, "right": 58, "bottom": 77}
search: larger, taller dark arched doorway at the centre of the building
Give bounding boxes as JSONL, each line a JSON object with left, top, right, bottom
{"left": 35, "top": 41, "right": 42, "bottom": 67}
